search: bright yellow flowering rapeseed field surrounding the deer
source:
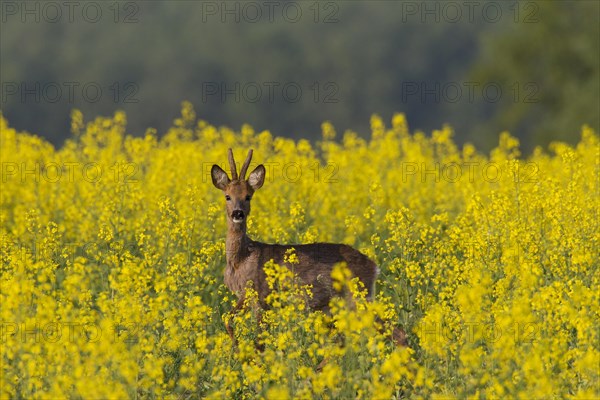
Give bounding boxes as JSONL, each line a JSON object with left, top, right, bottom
{"left": 0, "top": 103, "right": 600, "bottom": 399}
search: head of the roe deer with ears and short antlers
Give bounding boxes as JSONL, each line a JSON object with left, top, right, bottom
{"left": 210, "top": 149, "right": 265, "bottom": 231}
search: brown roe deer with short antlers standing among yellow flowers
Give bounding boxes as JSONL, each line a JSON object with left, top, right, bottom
{"left": 211, "top": 149, "right": 405, "bottom": 344}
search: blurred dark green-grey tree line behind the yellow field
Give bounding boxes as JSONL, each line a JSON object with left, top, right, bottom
{"left": 0, "top": 1, "right": 600, "bottom": 150}
